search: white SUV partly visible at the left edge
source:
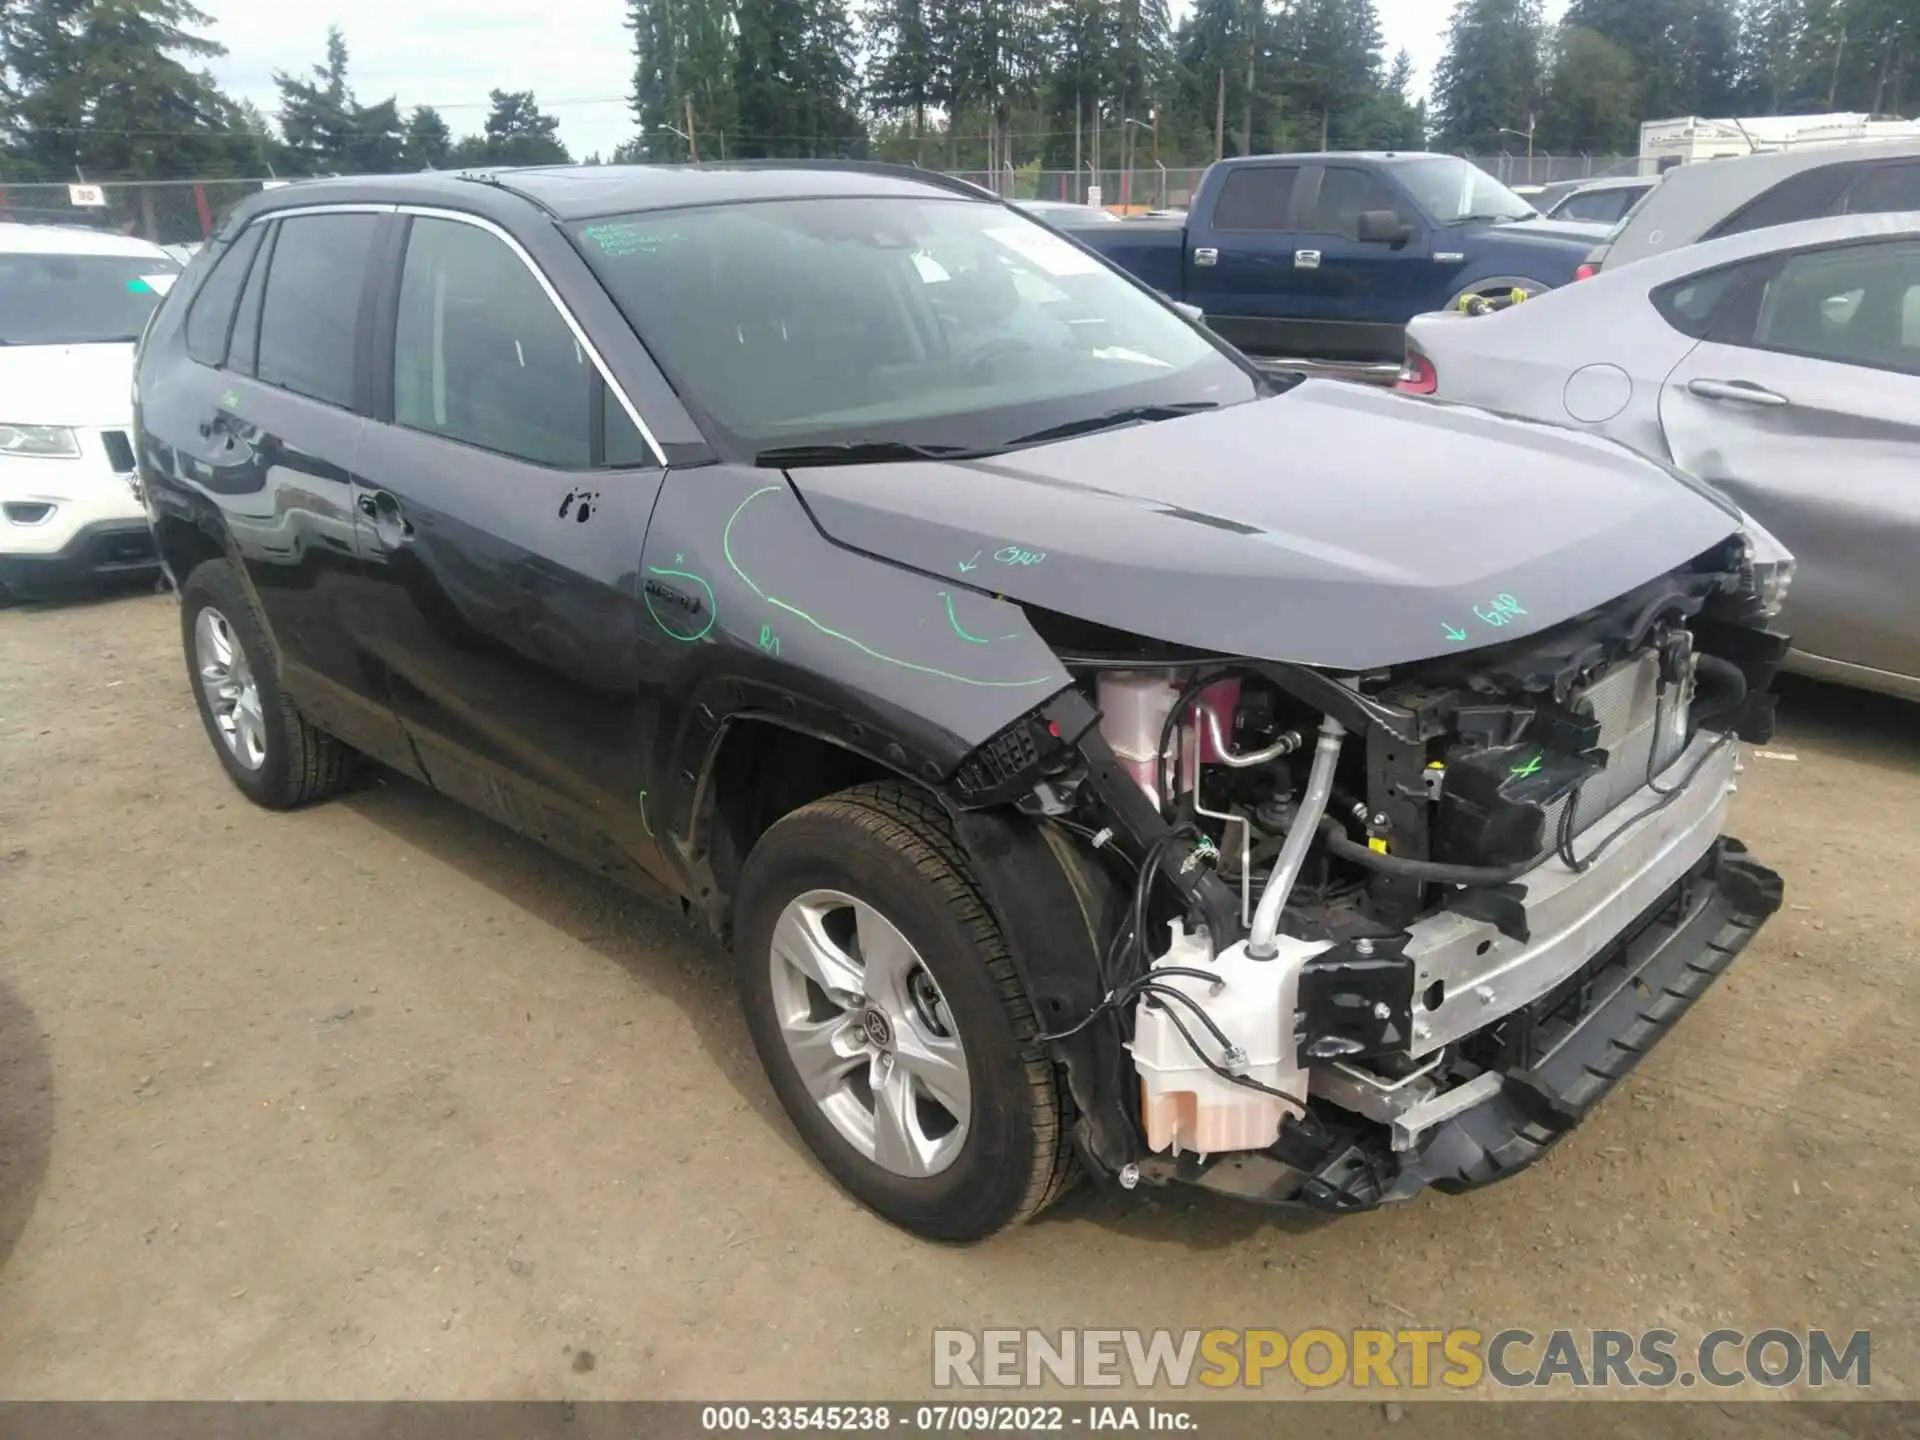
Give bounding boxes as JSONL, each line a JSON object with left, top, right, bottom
{"left": 0, "top": 225, "right": 180, "bottom": 597}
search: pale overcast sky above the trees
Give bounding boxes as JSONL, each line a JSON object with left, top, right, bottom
{"left": 200, "top": 0, "right": 1563, "bottom": 156}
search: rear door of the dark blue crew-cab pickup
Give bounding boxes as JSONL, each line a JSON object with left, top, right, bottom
{"left": 1187, "top": 163, "right": 1302, "bottom": 355}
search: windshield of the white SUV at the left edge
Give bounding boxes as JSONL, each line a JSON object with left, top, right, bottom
{"left": 0, "top": 252, "right": 180, "bottom": 346}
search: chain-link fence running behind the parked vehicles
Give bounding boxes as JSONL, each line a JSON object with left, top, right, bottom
{"left": 0, "top": 156, "right": 1642, "bottom": 246}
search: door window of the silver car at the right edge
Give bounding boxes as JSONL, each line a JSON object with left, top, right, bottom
{"left": 1753, "top": 240, "right": 1920, "bottom": 374}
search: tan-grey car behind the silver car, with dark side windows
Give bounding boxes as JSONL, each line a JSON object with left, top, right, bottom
{"left": 1582, "top": 140, "right": 1920, "bottom": 278}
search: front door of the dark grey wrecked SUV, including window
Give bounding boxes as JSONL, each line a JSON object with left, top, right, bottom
{"left": 359, "top": 211, "right": 668, "bottom": 890}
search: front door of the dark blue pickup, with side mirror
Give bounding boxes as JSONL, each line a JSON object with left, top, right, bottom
{"left": 1292, "top": 163, "right": 1432, "bottom": 361}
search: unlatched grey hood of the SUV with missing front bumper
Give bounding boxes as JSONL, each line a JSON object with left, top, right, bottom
{"left": 791, "top": 380, "right": 1736, "bottom": 670}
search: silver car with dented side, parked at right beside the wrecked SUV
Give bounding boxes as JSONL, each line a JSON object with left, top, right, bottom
{"left": 1402, "top": 213, "right": 1920, "bottom": 699}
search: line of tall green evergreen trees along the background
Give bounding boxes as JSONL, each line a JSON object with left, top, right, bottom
{"left": 0, "top": 0, "right": 1920, "bottom": 180}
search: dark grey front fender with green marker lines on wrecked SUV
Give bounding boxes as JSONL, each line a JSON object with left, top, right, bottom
{"left": 641, "top": 467, "right": 1071, "bottom": 847}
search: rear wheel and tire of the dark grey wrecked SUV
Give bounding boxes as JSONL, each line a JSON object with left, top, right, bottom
{"left": 180, "top": 561, "right": 353, "bottom": 810}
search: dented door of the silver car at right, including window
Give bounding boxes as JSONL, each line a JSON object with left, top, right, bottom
{"left": 1661, "top": 238, "right": 1920, "bottom": 676}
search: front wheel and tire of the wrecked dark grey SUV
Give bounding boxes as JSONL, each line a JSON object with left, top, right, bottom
{"left": 733, "top": 783, "right": 1075, "bottom": 1240}
